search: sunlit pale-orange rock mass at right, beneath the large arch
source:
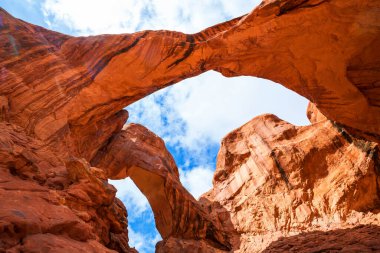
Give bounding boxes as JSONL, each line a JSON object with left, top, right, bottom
{"left": 203, "top": 106, "right": 380, "bottom": 252}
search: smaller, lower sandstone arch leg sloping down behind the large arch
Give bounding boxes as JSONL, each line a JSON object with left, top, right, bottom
{"left": 92, "top": 124, "right": 235, "bottom": 252}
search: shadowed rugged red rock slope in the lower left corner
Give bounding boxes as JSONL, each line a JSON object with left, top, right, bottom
{"left": 0, "top": 123, "right": 134, "bottom": 252}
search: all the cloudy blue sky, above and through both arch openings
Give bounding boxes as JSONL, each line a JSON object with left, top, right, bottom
{"left": 0, "top": 0, "right": 308, "bottom": 253}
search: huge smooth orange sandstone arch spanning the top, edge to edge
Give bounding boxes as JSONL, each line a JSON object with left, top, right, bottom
{"left": 0, "top": 0, "right": 380, "bottom": 159}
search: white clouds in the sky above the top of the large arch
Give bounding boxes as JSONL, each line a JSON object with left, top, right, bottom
{"left": 43, "top": 0, "right": 260, "bottom": 35}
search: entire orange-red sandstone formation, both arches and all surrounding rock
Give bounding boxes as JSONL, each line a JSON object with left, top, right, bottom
{"left": 0, "top": 0, "right": 380, "bottom": 252}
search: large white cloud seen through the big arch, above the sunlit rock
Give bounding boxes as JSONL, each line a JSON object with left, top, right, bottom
{"left": 169, "top": 72, "right": 308, "bottom": 145}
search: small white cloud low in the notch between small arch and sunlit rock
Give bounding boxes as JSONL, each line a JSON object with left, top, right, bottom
{"left": 179, "top": 166, "right": 214, "bottom": 199}
